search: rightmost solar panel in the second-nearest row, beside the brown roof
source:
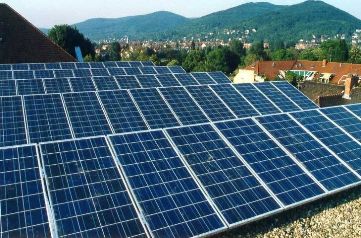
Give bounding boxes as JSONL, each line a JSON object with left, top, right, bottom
{"left": 272, "top": 81, "right": 318, "bottom": 110}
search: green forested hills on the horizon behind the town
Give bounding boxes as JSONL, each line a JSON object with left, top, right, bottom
{"left": 54, "top": 1, "right": 361, "bottom": 41}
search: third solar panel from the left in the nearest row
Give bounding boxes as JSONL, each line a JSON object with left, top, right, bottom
{"left": 110, "top": 131, "right": 225, "bottom": 237}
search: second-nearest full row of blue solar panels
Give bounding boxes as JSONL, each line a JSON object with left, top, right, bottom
{"left": 0, "top": 82, "right": 317, "bottom": 147}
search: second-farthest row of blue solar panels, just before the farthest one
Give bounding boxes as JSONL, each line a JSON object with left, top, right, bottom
{"left": 0, "top": 66, "right": 186, "bottom": 80}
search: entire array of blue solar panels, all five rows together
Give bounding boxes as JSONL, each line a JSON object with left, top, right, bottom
{"left": 0, "top": 62, "right": 361, "bottom": 237}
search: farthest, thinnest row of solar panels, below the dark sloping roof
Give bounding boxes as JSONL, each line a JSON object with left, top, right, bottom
{"left": 0, "top": 61, "right": 155, "bottom": 71}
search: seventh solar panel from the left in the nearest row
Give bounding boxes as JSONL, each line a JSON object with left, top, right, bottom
{"left": 291, "top": 111, "right": 361, "bottom": 174}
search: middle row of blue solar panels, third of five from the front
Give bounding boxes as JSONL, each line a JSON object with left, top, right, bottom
{"left": 0, "top": 72, "right": 230, "bottom": 96}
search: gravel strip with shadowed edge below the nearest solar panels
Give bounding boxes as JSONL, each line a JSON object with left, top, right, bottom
{"left": 217, "top": 187, "right": 361, "bottom": 238}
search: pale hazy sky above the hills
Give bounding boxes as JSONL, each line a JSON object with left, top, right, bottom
{"left": 0, "top": 0, "right": 361, "bottom": 27}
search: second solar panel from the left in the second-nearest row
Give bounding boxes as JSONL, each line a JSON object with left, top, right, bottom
{"left": 24, "top": 94, "right": 72, "bottom": 143}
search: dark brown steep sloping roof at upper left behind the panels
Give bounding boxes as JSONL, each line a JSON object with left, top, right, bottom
{"left": 0, "top": 3, "right": 75, "bottom": 64}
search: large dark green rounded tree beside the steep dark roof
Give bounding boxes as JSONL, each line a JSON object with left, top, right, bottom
{"left": 48, "top": 25, "right": 95, "bottom": 57}
